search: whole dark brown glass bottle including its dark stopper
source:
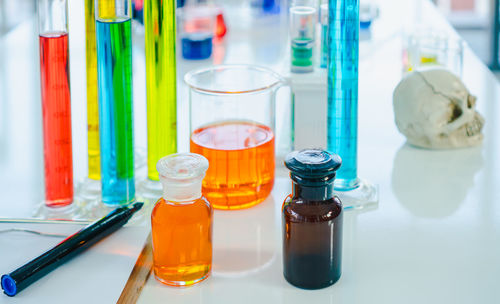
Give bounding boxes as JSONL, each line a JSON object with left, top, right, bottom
{"left": 282, "top": 149, "right": 342, "bottom": 289}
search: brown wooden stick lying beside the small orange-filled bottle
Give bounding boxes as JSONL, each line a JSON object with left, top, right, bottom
{"left": 116, "top": 232, "right": 153, "bottom": 304}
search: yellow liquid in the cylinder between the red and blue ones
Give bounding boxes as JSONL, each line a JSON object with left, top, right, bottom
{"left": 85, "top": 0, "right": 101, "bottom": 180}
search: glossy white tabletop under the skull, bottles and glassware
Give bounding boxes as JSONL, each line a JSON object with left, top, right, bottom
{"left": 0, "top": 0, "right": 500, "bottom": 304}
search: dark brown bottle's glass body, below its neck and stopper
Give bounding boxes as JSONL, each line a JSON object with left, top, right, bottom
{"left": 282, "top": 192, "right": 342, "bottom": 289}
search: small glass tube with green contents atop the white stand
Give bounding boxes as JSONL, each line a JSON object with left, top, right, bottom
{"left": 290, "top": 1, "right": 316, "bottom": 73}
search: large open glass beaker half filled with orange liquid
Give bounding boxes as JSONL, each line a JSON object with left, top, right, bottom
{"left": 184, "top": 65, "right": 293, "bottom": 209}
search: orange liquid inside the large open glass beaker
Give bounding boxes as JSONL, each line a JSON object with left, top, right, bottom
{"left": 190, "top": 122, "right": 275, "bottom": 209}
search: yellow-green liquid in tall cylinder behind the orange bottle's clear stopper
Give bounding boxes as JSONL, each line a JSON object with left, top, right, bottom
{"left": 144, "top": 0, "right": 177, "bottom": 181}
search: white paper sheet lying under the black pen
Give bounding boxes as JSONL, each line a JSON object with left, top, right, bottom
{"left": 0, "top": 223, "right": 149, "bottom": 304}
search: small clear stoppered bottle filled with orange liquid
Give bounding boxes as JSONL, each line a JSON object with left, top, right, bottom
{"left": 151, "top": 153, "right": 213, "bottom": 286}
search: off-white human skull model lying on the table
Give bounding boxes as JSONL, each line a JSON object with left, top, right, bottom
{"left": 393, "top": 68, "right": 484, "bottom": 149}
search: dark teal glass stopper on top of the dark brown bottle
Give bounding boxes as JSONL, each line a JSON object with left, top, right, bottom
{"left": 285, "top": 149, "right": 342, "bottom": 184}
